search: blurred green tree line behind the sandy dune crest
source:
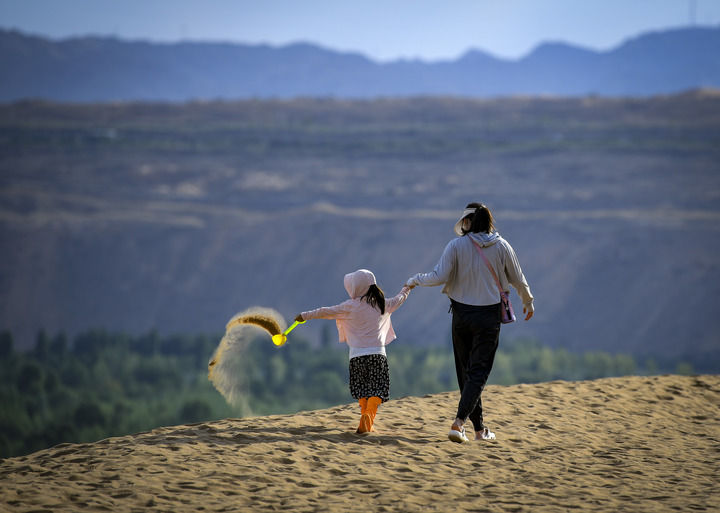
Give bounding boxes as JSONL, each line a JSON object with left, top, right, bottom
{"left": 0, "top": 331, "right": 692, "bottom": 457}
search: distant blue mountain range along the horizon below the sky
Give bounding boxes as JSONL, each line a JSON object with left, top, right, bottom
{"left": 0, "top": 27, "right": 720, "bottom": 102}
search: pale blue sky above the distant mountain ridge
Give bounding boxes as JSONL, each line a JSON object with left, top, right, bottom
{"left": 0, "top": 0, "right": 720, "bottom": 61}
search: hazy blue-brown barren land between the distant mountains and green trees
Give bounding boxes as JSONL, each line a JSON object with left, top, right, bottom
{"left": 0, "top": 94, "right": 720, "bottom": 372}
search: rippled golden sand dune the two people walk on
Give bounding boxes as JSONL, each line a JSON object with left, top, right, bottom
{"left": 0, "top": 375, "right": 720, "bottom": 513}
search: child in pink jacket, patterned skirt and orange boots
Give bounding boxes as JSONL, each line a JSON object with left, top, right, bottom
{"left": 295, "top": 269, "right": 412, "bottom": 433}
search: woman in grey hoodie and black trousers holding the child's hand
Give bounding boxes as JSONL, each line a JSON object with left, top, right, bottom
{"left": 407, "top": 203, "right": 535, "bottom": 443}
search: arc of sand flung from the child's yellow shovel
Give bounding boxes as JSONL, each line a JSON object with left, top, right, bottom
{"left": 208, "top": 306, "right": 285, "bottom": 415}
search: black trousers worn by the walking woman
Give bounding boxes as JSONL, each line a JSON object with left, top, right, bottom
{"left": 451, "top": 301, "right": 500, "bottom": 431}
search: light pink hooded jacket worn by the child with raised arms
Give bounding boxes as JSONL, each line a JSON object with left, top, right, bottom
{"left": 301, "top": 269, "right": 410, "bottom": 347}
